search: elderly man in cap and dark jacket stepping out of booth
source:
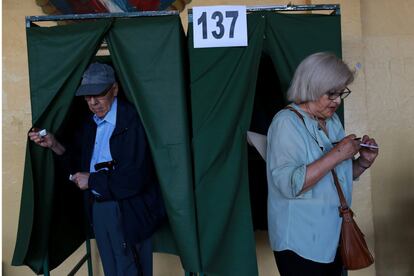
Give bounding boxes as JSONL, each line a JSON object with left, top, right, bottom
{"left": 29, "top": 63, "right": 165, "bottom": 276}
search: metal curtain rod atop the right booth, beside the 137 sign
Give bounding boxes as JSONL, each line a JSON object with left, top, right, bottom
{"left": 188, "top": 4, "right": 341, "bottom": 23}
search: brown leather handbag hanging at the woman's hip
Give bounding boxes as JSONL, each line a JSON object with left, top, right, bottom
{"left": 332, "top": 170, "right": 374, "bottom": 270}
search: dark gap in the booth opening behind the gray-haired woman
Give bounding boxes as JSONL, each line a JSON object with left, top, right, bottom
{"left": 248, "top": 52, "right": 287, "bottom": 230}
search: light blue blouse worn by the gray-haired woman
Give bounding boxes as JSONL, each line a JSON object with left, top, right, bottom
{"left": 266, "top": 104, "right": 352, "bottom": 263}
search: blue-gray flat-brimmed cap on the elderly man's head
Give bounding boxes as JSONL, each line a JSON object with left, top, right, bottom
{"left": 76, "top": 62, "right": 115, "bottom": 96}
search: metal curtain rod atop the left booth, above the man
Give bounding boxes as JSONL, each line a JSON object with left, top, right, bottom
{"left": 26, "top": 11, "right": 179, "bottom": 28}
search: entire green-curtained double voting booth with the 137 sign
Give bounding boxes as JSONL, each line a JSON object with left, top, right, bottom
{"left": 13, "top": 5, "right": 341, "bottom": 276}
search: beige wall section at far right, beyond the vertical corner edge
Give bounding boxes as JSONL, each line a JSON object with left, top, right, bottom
{"left": 361, "top": 0, "right": 414, "bottom": 275}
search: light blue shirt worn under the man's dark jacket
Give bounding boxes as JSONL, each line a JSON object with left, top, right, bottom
{"left": 89, "top": 97, "right": 118, "bottom": 195}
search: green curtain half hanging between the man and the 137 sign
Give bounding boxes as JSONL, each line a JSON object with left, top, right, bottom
{"left": 108, "top": 16, "right": 200, "bottom": 271}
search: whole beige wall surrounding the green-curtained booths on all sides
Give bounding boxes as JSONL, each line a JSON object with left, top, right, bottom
{"left": 2, "top": 0, "right": 414, "bottom": 276}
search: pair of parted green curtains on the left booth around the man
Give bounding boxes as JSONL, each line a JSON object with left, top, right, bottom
{"left": 13, "top": 16, "right": 200, "bottom": 273}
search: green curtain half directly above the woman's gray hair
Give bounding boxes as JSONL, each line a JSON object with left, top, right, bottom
{"left": 261, "top": 13, "right": 343, "bottom": 117}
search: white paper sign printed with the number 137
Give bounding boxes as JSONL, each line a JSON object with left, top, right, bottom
{"left": 193, "top": 6, "right": 247, "bottom": 48}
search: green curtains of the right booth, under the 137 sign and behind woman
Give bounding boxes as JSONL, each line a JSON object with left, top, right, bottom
{"left": 188, "top": 12, "right": 341, "bottom": 276}
